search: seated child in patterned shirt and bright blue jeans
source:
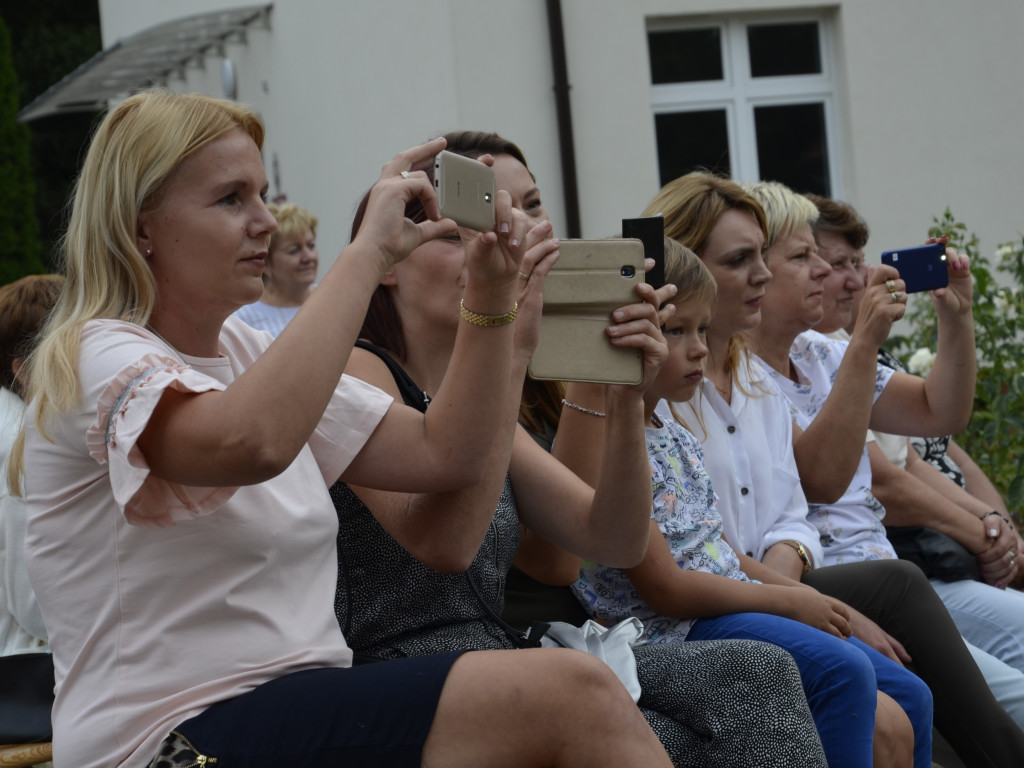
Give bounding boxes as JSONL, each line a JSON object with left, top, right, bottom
{"left": 562, "top": 240, "right": 932, "bottom": 768}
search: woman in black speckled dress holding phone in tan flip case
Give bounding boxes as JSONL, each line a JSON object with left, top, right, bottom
{"left": 331, "top": 134, "right": 825, "bottom": 768}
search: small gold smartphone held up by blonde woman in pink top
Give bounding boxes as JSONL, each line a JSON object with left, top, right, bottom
{"left": 434, "top": 150, "right": 495, "bottom": 232}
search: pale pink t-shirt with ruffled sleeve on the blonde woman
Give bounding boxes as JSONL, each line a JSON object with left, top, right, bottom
{"left": 26, "top": 318, "right": 391, "bottom": 768}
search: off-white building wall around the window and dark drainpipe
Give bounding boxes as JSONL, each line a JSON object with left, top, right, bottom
{"left": 100, "top": 0, "right": 1024, "bottom": 269}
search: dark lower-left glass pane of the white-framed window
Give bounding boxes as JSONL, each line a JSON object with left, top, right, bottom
{"left": 654, "top": 110, "right": 730, "bottom": 184}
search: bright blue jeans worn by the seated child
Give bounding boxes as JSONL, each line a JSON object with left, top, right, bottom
{"left": 686, "top": 613, "right": 932, "bottom": 768}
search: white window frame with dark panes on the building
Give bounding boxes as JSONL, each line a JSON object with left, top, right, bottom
{"left": 647, "top": 12, "right": 844, "bottom": 198}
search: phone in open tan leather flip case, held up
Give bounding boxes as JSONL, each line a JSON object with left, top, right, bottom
{"left": 529, "top": 239, "right": 644, "bottom": 384}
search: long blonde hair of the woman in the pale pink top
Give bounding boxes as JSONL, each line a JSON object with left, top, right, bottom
{"left": 8, "top": 90, "right": 263, "bottom": 487}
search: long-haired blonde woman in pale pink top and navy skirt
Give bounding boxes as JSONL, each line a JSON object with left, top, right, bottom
{"left": 11, "top": 91, "right": 669, "bottom": 768}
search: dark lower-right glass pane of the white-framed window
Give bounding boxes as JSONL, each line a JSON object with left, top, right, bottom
{"left": 754, "top": 101, "right": 831, "bottom": 196}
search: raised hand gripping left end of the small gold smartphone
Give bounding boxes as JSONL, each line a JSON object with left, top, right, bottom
{"left": 355, "top": 137, "right": 456, "bottom": 270}
